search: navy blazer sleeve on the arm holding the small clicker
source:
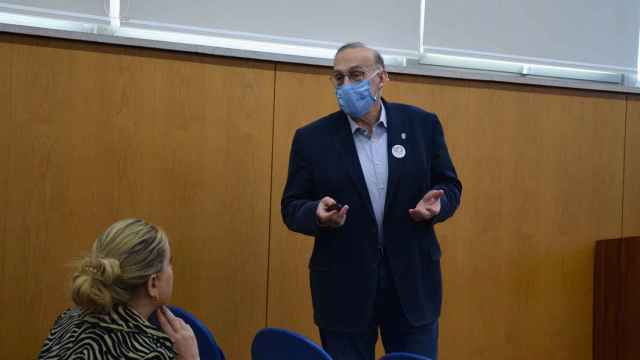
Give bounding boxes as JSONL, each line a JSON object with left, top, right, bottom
{"left": 280, "top": 129, "right": 320, "bottom": 236}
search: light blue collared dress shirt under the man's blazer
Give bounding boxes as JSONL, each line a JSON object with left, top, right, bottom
{"left": 349, "top": 104, "right": 389, "bottom": 246}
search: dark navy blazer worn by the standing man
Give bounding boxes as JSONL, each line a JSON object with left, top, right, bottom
{"left": 281, "top": 102, "right": 462, "bottom": 331}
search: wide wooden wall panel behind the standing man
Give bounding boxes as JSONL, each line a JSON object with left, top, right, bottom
{"left": 268, "top": 65, "right": 625, "bottom": 360}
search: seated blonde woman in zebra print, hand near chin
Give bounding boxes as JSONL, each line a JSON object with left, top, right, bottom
{"left": 39, "top": 219, "right": 199, "bottom": 360}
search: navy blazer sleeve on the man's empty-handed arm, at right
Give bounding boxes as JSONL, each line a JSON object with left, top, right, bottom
{"left": 431, "top": 116, "right": 462, "bottom": 224}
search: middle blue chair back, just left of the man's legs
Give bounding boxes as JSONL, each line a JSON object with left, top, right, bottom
{"left": 251, "top": 328, "right": 331, "bottom": 360}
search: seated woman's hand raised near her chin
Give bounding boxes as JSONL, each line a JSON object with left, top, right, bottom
{"left": 156, "top": 306, "right": 200, "bottom": 360}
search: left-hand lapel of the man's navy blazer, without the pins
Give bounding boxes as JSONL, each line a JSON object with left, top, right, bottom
{"left": 335, "top": 112, "right": 375, "bottom": 220}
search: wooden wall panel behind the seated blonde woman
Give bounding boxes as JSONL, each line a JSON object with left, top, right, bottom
{"left": 0, "top": 34, "right": 274, "bottom": 359}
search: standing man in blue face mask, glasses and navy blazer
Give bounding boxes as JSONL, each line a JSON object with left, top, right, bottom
{"left": 281, "top": 43, "right": 462, "bottom": 360}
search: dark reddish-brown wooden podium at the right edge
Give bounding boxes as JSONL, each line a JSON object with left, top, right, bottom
{"left": 593, "top": 237, "right": 640, "bottom": 360}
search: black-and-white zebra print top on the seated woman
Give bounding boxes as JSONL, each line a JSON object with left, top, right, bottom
{"left": 38, "top": 305, "right": 176, "bottom": 360}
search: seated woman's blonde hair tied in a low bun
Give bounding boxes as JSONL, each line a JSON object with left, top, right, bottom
{"left": 71, "top": 219, "right": 168, "bottom": 314}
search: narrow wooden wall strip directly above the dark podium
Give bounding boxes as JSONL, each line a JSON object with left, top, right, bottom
{"left": 622, "top": 96, "right": 640, "bottom": 236}
